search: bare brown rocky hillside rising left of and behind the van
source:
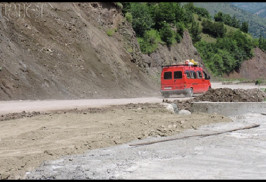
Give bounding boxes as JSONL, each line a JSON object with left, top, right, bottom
{"left": 0, "top": 2, "right": 201, "bottom": 100}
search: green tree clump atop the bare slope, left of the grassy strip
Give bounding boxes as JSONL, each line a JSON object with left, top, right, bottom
{"left": 122, "top": 2, "right": 197, "bottom": 54}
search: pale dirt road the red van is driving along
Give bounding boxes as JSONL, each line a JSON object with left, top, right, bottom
{"left": 0, "top": 82, "right": 266, "bottom": 114}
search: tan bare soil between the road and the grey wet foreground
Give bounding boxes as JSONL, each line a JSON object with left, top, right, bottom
{"left": 0, "top": 104, "right": 231, "bottom": 179}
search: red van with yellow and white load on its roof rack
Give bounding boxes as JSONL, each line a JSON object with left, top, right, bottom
{"left": 161, "top": 64, "right": 211, "bottom": 98}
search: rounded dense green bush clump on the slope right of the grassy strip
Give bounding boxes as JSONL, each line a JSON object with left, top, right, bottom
{"left": 195, "top": 30, "right": 253, "bottom": 76}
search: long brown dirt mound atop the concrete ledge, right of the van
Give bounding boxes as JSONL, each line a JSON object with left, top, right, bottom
{"left": 194, "top": 88, "right": 266, "bottom": 102}
